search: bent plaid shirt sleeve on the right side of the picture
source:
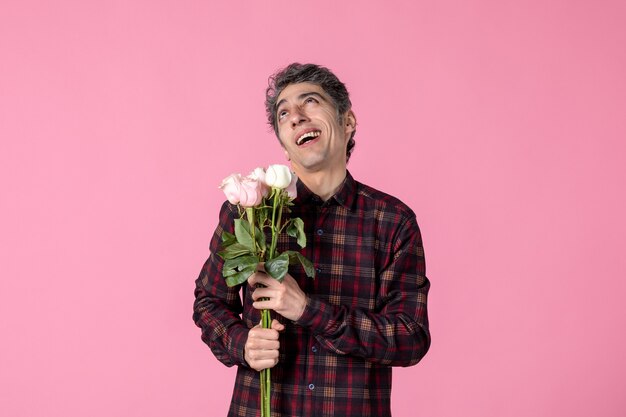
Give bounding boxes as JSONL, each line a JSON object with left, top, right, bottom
{"left": 296, "top": 216, "right": 430, "bottom": 366}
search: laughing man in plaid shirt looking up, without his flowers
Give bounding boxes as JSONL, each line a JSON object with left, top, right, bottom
{"left": 194, "top": 64, "right": 430, "bottom": 417}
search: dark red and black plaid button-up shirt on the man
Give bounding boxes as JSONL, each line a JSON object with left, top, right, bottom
{"left": 193, "top": 173, "right": 430, "bottom": 417}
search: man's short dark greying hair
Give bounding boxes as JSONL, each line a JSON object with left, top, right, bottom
{"left": 265, "top": 62, "right": 356, "bottom": 160}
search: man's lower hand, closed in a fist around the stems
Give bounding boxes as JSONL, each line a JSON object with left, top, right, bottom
{"left": 244, "top": 320, "right": 285, "bottom": 371}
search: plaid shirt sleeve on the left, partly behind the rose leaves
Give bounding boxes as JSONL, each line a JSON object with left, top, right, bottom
{"left": 193, "top": 202, "right": 249, "bottom": 366}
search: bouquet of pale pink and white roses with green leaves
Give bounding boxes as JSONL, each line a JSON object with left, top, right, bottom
{"left": 217, "top": 165, "right": 315, "bottom": 417}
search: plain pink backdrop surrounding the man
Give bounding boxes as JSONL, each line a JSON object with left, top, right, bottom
{"left": 0, "top": 0, "right": 626, "bottom": 417}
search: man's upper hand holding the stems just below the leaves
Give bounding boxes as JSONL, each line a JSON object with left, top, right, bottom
{"left": 248, "top": 271, "right": 306, "bottom": 321}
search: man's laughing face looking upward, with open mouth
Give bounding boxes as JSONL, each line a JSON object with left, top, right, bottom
{"left": 276, "top": 83, "right": 355, "bottom": 176}
